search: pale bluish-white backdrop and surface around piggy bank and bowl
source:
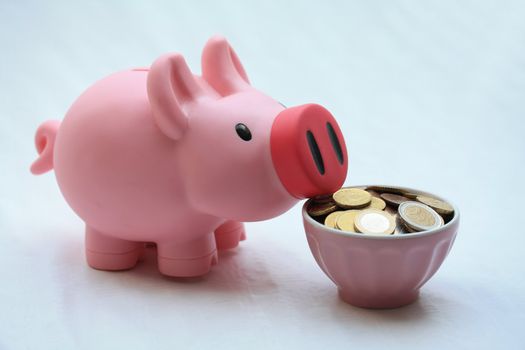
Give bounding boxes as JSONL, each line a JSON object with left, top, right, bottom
{"left": 0, "top": 1, "right": 525, "bottom": 349}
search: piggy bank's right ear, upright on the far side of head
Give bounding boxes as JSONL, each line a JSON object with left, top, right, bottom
{"left": 201, "top": 36, "right": 250, "bottom": 96}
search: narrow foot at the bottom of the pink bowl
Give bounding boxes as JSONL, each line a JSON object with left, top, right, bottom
{"left": 338, "top": 288, "right": 419, "bottom": 309}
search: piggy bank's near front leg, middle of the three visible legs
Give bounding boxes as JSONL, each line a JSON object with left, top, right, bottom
{"left": 157, "top": 233, "right": 217, "bottom": 277}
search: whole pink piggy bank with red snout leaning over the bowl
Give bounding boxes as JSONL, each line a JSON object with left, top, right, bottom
{"left": 31, "top": 36, "right": 348, "bottom": 277}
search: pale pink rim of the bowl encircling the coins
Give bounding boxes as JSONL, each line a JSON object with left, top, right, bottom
{"left": 301, "top": 185, "right": 460, "bottom": 240}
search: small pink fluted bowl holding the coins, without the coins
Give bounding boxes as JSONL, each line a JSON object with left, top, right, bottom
{"left": 302, "top": 186, "right": 459, "bottom": 308}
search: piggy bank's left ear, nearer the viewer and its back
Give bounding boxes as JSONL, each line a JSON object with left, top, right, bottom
{"left": 147, "top": 53, "right": 204, "bottom": 140}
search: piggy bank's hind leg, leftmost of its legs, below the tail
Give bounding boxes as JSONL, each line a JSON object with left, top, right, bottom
{"left": 86, "top": 226, "right": 144, "bottom": 271}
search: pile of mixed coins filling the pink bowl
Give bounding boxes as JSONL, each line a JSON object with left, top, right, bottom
{"left": 306, "top": 186, "right": 454, "bottom": 235}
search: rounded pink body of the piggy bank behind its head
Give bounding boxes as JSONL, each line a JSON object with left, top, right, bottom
{"left": 54, "top": 71, "right": 185, "bottom": 239}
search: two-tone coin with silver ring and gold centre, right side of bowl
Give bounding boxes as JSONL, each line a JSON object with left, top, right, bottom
{"left": 398, "top": 201, "right": 443, "bottom": 231}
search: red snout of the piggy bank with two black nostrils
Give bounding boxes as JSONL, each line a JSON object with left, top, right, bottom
{"left": 270, "top": 104, "right": 348, "bottom": 198}
